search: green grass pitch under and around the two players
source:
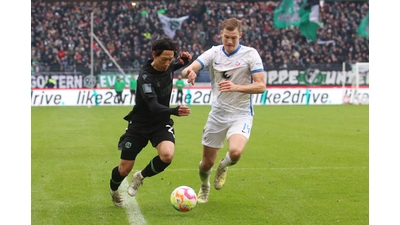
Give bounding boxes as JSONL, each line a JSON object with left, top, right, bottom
{"left": 31, "top": 105, "right": 369, "bottom": 225}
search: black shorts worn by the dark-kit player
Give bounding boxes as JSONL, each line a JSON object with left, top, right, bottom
{"left": 118, "top": 120, "right": 175, "bottom": 160}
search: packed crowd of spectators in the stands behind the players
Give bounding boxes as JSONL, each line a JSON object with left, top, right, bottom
{"left": 31, "top": 0, "right": 369, "bottom": 74}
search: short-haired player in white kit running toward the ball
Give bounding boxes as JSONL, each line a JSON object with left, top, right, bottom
{"left": 182, "top": 18, "right": 266, "bottom": 203}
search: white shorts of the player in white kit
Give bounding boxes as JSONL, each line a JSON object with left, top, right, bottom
{"left": 202, "top": 116, "right": 253, "bottom": 148}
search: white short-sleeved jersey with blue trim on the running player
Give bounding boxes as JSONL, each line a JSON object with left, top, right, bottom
{"left": 197, "top": 44, "right": 264, "bottom": 121}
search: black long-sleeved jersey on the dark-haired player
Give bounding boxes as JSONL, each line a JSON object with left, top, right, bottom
{"left": 124, "top": 60, "right": 183, "bottom": 131}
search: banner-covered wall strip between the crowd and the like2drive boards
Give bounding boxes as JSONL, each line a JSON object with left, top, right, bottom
{"left": 31, "top": 69, "right": 369, "bottom": 88}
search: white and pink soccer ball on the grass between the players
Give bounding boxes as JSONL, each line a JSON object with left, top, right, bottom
{"left": 170, "top": 186, "right": 197, "bottom": 212}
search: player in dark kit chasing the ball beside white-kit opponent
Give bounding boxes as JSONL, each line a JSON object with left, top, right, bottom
{"left": 110, "top": 36, "right": 195, "bottom": 206}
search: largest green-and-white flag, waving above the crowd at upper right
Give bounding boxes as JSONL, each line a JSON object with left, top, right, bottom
{"left": 274, "top": 0, "right": 319, "bottom": 41}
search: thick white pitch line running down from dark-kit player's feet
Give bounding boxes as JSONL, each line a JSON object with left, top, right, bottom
{"left": 120, "top": 179, "right": 147, "bottom": 225}
